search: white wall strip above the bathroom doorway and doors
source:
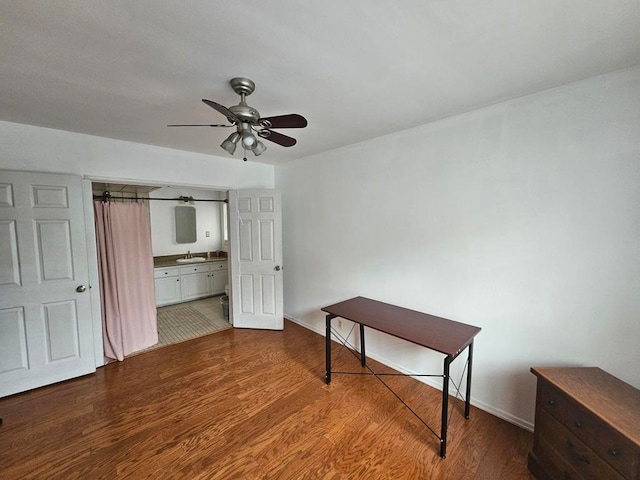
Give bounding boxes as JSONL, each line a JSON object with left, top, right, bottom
{"left": 0, "top": 121, "right": 273, "bottom": 190}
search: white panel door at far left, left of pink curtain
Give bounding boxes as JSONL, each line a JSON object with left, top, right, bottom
{"left": 0, "top": 170, "right": 95, "bottom": 397}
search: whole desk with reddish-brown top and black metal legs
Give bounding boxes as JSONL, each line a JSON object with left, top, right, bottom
{"left": 322, "top": 297, "right": 480, "bottom": 458}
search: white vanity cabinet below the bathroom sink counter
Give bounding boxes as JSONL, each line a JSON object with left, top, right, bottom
{"left": 154, "top": 260, "right": 229, "bottom": 307}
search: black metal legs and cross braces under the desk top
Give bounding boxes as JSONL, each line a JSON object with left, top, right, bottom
{"left": 325, "top": 314, "right": 473, "bottom": 458}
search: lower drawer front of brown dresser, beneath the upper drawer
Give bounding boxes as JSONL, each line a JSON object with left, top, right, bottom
{"left": 534, "top": 411, "right": 624, "bottom": 480}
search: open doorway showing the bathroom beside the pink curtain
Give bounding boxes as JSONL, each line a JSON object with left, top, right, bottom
{"left": 92, "top": 182, "right": 231, "bottom": 355}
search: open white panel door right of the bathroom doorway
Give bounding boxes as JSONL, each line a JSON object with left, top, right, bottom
{"left": 229, "top": 190, "right": 284, "bottom": 330}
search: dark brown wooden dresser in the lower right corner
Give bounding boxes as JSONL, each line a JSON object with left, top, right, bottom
{"left": 529, "top": 368, "right": 640, "bottom": 480}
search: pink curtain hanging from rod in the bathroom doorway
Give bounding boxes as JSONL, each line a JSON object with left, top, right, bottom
{"left": 94, "top": 201, "right": 158, "bottom": 360}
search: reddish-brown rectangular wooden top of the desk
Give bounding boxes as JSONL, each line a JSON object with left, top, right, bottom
{"left": 322, "top": 297, "right": 481, "bottom": 358}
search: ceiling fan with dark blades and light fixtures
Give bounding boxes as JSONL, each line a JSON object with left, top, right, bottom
{"left": 167, "top": 77, "right": 307, "bottom": 161}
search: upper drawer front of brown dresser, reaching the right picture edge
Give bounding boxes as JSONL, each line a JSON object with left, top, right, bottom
{"left": 565, "top": 404, "right": 640, "bottom": 479}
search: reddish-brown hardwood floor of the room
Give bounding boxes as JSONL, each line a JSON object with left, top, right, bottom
{"left": 0, "top": 322, "right": 532, "bottom": 480}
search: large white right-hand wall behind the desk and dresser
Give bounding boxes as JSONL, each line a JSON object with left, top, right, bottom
{"left": 276, "top": 68, "right": 640, "bottom": 428}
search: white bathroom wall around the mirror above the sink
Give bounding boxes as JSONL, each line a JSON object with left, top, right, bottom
{"left": 149, "top": 187, "right": 227, "bottom": 256}
